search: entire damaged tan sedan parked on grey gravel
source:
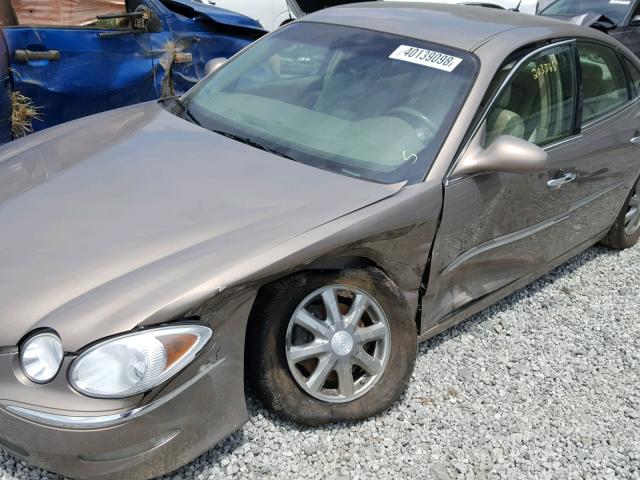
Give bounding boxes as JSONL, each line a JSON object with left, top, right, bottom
{"left": 0, "top": 2, "right": 640, "bottom": 478}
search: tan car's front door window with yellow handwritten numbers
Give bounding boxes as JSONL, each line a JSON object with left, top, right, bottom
{"left": 485, "top": 46, "right": 576, "bottom": 146}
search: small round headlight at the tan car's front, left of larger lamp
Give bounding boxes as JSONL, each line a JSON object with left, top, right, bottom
{"left": 20, "top": 332, "right": 64, "bottom": 383}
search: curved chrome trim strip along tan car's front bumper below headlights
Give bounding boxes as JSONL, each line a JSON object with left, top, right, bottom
{"left": 6, "top": 358, "right": 225, "bottom": 430}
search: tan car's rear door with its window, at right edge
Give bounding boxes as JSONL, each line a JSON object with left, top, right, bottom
{"left": 563, "top": 40, "right": 640, "bottom": 241}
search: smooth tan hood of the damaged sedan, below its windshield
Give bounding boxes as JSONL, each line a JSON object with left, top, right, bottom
{"left": 0, "top": 102, "right": 402, "bottom": 351}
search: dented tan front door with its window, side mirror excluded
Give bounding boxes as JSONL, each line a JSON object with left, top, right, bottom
{"left": 422, "top": 43, "right": 580, "bottom": 329}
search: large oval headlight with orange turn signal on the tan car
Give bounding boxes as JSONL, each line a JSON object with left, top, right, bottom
{"left": 69, "top": 325, "right": 211, "bottom": 398}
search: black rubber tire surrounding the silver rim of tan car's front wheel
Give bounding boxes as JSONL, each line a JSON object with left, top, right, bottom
{"left": 250, "top": 268, "right": 417, "bottom": 425}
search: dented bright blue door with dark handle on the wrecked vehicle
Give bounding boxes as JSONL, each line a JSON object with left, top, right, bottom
{"left": 2, "top": 4, "right": 159, "bottom": 131}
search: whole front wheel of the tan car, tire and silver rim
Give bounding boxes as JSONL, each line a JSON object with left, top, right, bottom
{"left": 247, "top": 268, "right": 417, "bottom": 425}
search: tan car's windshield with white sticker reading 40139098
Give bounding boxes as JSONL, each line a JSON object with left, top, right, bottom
{"left": 182, "top": 23, "right": 476, "bottom": 183}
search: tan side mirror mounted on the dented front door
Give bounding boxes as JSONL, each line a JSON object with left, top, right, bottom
{"left": 454, "top": 126, "right": 548, "bottom": 175}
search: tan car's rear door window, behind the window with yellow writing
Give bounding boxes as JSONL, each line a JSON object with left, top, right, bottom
{"left": 578, "top": 42, "right": 629, "bottom": 122}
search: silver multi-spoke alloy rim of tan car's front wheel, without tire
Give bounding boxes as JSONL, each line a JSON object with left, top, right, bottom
{"left": 285, "top": 285, "right": 391, "bottom": 403}
